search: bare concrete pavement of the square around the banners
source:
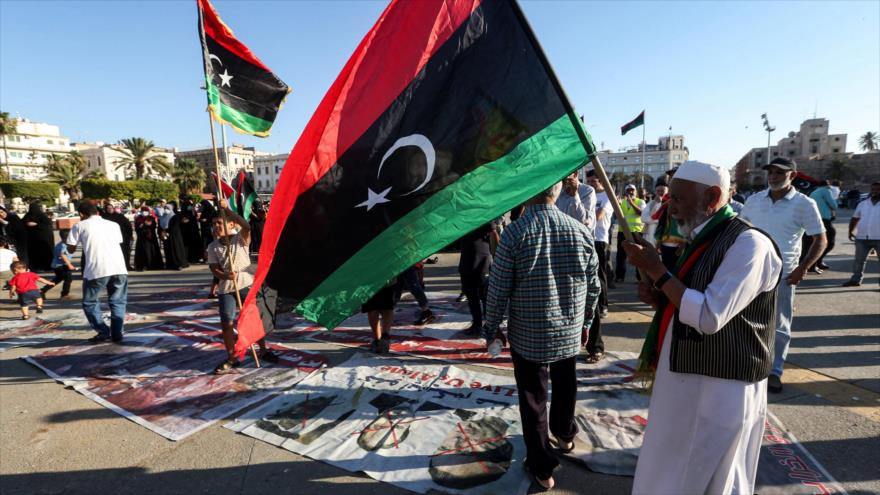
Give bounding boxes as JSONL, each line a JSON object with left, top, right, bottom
{"left": 0, "top": 214, "right": 880, "bottom": 495}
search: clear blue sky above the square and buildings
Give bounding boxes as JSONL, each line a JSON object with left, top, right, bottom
{"left": 0, "top": 0, "right": 880, "bottom": 166}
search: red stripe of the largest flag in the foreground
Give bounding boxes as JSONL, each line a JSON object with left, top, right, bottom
{"left": 234, "top": 0, "right": 481, "bottom": 356}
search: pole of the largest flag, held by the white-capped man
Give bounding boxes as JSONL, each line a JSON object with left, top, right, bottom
{"left": 509, "top": 0, "right": 651, "bottom": 280}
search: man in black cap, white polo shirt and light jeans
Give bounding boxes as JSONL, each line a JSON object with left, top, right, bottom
{"left": 740, "top": 158, "right": 828, "bottom": 393}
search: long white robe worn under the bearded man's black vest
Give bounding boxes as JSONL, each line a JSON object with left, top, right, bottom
{"left": 633, "top": 224, "right": 785, "bottom": 495}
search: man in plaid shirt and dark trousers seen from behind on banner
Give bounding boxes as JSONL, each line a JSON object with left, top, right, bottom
{"left": 483, "top": 184, "right": 600, "bottom": 488}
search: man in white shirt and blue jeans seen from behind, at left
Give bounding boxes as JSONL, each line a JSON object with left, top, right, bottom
{"left": 67, "top": 201, "right": 128, "bottom": 343}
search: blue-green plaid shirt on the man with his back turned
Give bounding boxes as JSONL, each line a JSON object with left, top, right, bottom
{"left": 483, "top": 204, "right": 600, "bottom": 363}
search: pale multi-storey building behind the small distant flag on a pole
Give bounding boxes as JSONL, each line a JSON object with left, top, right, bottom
{"left": 587, "top": 135, "right": 689, "bottom": 188}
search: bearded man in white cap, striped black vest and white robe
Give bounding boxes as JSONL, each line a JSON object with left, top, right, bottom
{"left": 624, "top": 162, "right": 782, "bottom": 494}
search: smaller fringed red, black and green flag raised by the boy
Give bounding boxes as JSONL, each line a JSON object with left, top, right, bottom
{"left": 196, "top": 0, "right": 290, "bottom": 136}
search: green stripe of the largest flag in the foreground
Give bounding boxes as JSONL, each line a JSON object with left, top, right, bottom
{"left": 296, "top": 115, "right": 593, "bottom": 329}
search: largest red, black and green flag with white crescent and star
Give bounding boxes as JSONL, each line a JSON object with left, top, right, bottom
{"left": 237, "top": 0, "right": 595, "bottom": 353}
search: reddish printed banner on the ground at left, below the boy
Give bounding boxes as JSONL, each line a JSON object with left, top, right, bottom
{"left": 24, "top": 322, "right": 326, "bottom": 440}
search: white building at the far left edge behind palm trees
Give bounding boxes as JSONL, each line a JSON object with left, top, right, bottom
{"left": 0, "top": 119, "right": 72, "bottom": 180}
